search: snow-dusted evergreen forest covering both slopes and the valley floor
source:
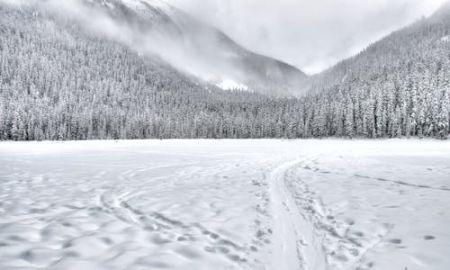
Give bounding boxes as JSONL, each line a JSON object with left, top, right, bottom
{"left": 0, "top": 5, "right": 450, "bottom": 140}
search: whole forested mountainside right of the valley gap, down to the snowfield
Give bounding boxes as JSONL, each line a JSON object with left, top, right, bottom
{"left": 296, "top": 3, "right": 450, "bottom": 138}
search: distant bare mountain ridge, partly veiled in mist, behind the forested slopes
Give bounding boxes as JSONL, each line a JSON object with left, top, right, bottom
{"left": 88, "top": 0, "right": 306, "bottom": 96}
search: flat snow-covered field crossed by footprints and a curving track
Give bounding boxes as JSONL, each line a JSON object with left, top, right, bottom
{"left": 0, "top": 140, "right": 450, "bottom": 270}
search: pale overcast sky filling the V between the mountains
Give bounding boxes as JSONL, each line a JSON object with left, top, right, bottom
{"left": 167, "top": 0, "right": 445, "bottom": 74}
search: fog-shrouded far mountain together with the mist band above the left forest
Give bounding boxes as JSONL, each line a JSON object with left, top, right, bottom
{"left": 0, "top": 0, "right": 305, "bottom": 96}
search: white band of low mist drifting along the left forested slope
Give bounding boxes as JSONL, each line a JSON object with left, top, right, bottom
{"left": 0, "top": 0, "right": 243, "bottom": 81}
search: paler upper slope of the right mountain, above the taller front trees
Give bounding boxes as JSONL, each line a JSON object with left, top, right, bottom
{"left": 301, "top": 2, "right": 450, "bottom": 95}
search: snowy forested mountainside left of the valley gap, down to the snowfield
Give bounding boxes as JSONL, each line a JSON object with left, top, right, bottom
{"left": 0, "top": 0, "right": 306, "bottom": 140}
